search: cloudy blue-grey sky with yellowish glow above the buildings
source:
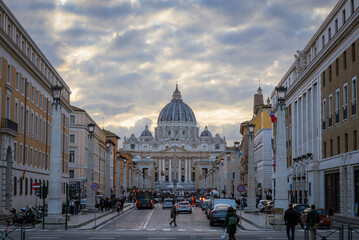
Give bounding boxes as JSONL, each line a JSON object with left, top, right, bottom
{"left": 4, "top": 0, "right": 338, "bottom": 144}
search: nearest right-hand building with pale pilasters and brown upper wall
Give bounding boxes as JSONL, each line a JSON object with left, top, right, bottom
{"left": 272, "top": 0, "right": 359, "bottom": 217}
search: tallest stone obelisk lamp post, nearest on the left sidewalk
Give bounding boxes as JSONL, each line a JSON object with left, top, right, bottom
{"left": 47, "top": 85, "right": 65, "bottom": 224}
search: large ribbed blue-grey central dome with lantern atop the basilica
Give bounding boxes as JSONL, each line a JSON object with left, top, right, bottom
{"left": 158, "top": 85, "right": 196, "bottom": 123}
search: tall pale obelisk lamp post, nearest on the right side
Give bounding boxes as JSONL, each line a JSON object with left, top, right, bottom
{"left": 275, "top": 86, "right": 288, "bottom": 209}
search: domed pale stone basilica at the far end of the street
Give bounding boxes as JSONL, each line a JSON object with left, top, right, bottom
{"left": 121, "top": 85, "right": 226, "bottom": 190}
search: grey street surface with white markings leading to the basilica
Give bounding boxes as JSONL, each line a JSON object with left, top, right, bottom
{"left": 3, "top": 205, "right": 347, "bottom": 240}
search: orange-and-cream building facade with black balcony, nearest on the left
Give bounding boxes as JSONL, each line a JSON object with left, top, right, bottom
{"left": 0, "top": 1, "right": 71, "bottom": 214}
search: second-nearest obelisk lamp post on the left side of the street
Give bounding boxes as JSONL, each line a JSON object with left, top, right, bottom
{"left": 86, "top": 123, "right": 96, "bottom": 212}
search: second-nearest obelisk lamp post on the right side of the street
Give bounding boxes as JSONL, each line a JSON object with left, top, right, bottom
{"left": 245, "top": 124, "right": 256, "bottom": 212}
